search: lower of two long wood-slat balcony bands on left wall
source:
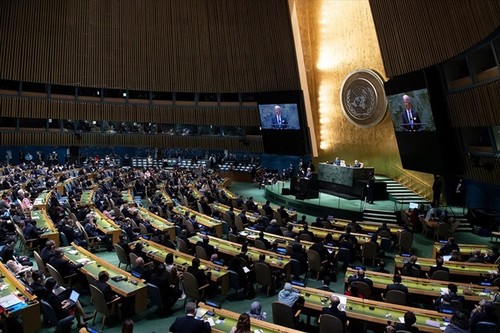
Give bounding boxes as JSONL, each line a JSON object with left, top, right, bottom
{"left": 0, "top": 131, "right": 264, "bottom": 153}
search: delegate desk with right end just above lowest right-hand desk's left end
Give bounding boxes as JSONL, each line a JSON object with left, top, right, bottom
{"left": 189, "top": 234, "right": 291, "bottom": 278}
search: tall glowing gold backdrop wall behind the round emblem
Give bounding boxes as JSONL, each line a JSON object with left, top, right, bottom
{"left": 290, "top": 0, "right": 429, "bottom": 181}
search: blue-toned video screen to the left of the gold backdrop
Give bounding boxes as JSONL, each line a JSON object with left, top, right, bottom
{"left": 259, "top": 103, "right": 300, "bottom": 130}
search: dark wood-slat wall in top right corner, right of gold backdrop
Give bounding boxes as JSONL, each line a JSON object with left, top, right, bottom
{"left": 370, "top": 0, "right": 500, "bottom": 77}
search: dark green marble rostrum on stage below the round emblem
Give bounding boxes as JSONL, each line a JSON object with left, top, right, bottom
{"left": 318, "top": 163, "right": 378, "bottom": 198}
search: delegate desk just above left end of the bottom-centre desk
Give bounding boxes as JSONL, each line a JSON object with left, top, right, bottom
{"left": 130, "top": 239, "right": 229, "bottom": 295}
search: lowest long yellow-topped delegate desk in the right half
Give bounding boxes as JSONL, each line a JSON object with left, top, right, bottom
{"left": 293, "top": 286, "right": 449, "bottom": 333}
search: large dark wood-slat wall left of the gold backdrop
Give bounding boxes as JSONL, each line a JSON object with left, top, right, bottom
{"left": 0, "top": 0, "right": 300, "bottom": 92}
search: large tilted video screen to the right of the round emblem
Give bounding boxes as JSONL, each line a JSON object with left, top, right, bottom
{"left": 387, "top": 88, "right": 436, "bottom": 132}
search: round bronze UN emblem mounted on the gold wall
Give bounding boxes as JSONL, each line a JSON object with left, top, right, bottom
{"left": 340, "top": 69, "right": 387, "bottom": 127}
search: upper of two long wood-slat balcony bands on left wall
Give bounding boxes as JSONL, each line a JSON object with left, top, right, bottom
{"left": 0, "top": 96, "right": 260, "bottom": 126}
